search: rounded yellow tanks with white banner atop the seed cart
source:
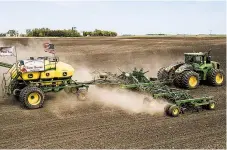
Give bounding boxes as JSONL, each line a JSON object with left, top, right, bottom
{"left": 9, "top": 57, "right": 74, "bottom": 81}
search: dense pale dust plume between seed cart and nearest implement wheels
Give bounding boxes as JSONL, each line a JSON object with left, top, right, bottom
{"left": 88, "top": 86, "right": 168, "bottom": 115}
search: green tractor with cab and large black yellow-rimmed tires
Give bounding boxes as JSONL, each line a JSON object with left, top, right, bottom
{"left": 157, "top": 51, "right": 225, "bottom": 89}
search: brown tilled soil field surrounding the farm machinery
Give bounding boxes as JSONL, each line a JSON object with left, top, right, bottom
{"left": 0, "top": 38, "right": 226, "bottom": 149}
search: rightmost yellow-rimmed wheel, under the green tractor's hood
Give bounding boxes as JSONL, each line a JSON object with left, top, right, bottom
{"left": 207, "top": 68, "right": 225, "bottom": 86}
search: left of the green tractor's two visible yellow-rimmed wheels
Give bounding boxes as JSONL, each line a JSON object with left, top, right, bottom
{"left": 180, "top": 71, "right": 200, "bottom": 89}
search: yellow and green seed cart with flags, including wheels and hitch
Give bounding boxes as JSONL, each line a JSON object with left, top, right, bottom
{"left": 0, "top": 43, "right": 89, "bottom": 109}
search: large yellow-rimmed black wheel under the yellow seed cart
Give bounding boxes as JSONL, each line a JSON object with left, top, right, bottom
{"left": 19, "top": 86, "right": 45, "bottom": 109}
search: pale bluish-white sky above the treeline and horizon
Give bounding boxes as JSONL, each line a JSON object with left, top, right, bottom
{"left": 0, "top": 0, "right": 226, "bottom": 35}
